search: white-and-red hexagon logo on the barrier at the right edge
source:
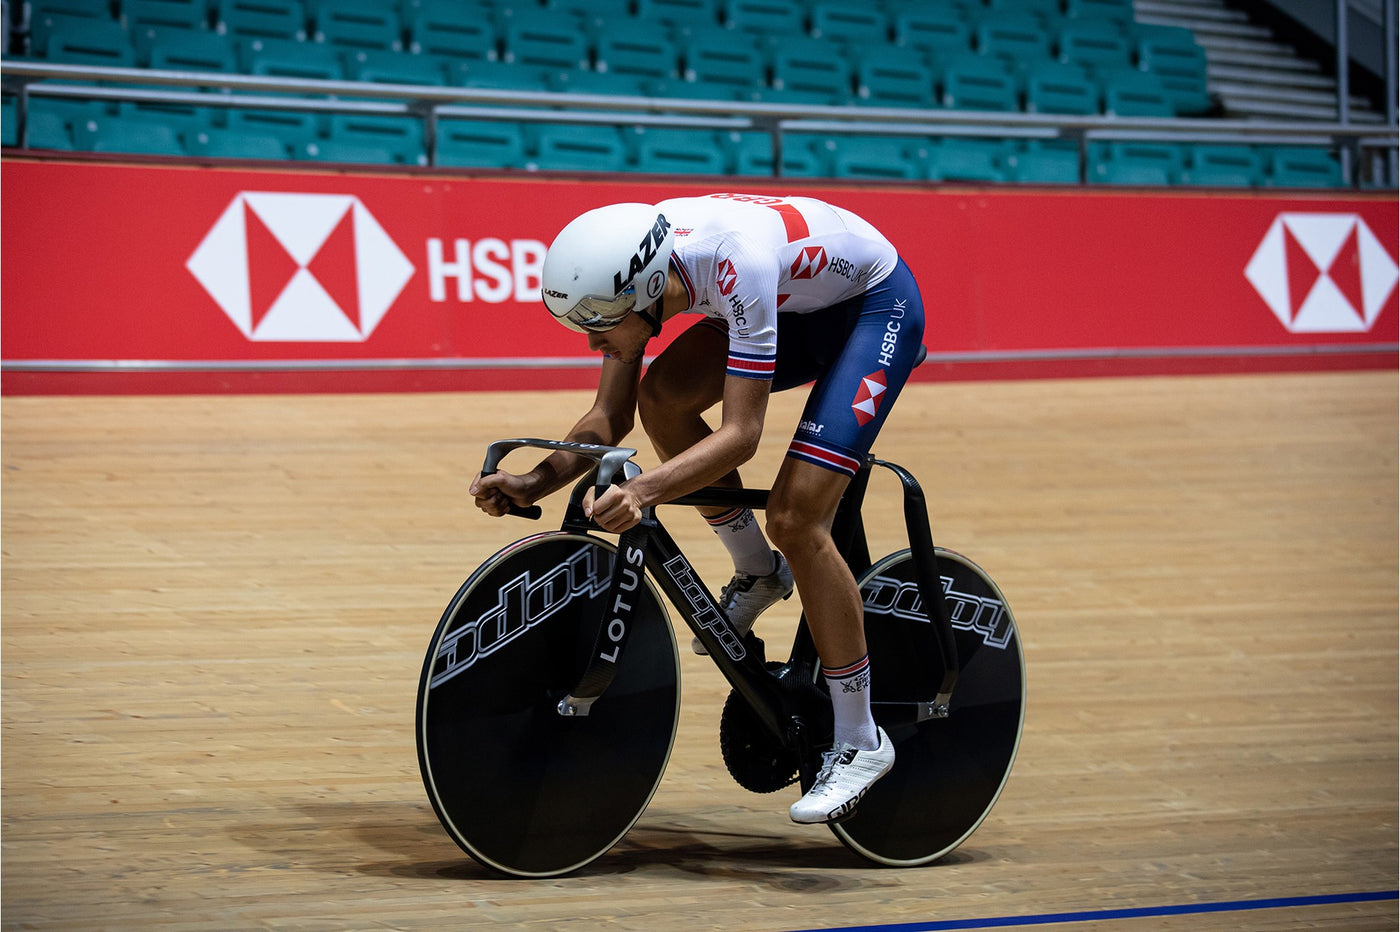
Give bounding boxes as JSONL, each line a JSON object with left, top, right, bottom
{"left": 1245, "top": 214, "right": 1397, "bottom": 333}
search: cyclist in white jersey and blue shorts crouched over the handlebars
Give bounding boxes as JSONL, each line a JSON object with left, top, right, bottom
{"left": 470, "top": 195, "right": 924, "bottom": 823}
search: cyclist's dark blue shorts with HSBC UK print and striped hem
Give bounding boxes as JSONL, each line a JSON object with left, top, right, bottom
{"left": 773, "top": 259, "right": 924, "bottom": 476}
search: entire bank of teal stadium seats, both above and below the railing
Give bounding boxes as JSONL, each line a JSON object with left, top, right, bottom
{"left": 6, "top": 0, "right": 1340, "bottom": 186}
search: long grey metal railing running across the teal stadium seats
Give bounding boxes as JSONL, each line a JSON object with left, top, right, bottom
{"left": 0, "top": 60, "right": 1397, "bottom": 188}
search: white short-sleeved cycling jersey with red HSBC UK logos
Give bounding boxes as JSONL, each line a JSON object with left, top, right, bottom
{"left": 658, "top": 195, "right": 899, "bottom": 379}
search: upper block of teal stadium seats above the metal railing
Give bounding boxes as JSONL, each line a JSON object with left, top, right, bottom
{"left": 10, "top": 0, "right": 1211, "bottom": 116}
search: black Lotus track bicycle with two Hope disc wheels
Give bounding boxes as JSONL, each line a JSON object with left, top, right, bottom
{"left": 416, "top": 439, "right": 1025, "bottom": 877}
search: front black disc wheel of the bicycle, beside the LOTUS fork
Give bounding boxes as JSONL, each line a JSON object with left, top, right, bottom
{"left": 417, "top": 532, "right": 680, "bottom": 877}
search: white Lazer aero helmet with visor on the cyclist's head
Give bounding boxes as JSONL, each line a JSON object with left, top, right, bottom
{"left": 540, "top": 204, "right": 675, "bottom": 333}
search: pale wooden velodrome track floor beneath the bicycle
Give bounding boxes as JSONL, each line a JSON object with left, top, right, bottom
{"left": 0, "top": 371, "right": 1397, "bottom": 931}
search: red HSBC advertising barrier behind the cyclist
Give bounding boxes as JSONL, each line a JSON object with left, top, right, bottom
{"left": 0, "top": 160, "right": 1397, "bottom": 393}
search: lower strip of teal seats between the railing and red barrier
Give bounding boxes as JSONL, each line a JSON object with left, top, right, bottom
{"left": 3, "top": 94, "right": 1341, "bottom": 188}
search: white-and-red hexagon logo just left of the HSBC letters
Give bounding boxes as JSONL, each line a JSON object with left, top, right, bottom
{"left": 185, "top": 192, "right": 413, "bottom": 343}
